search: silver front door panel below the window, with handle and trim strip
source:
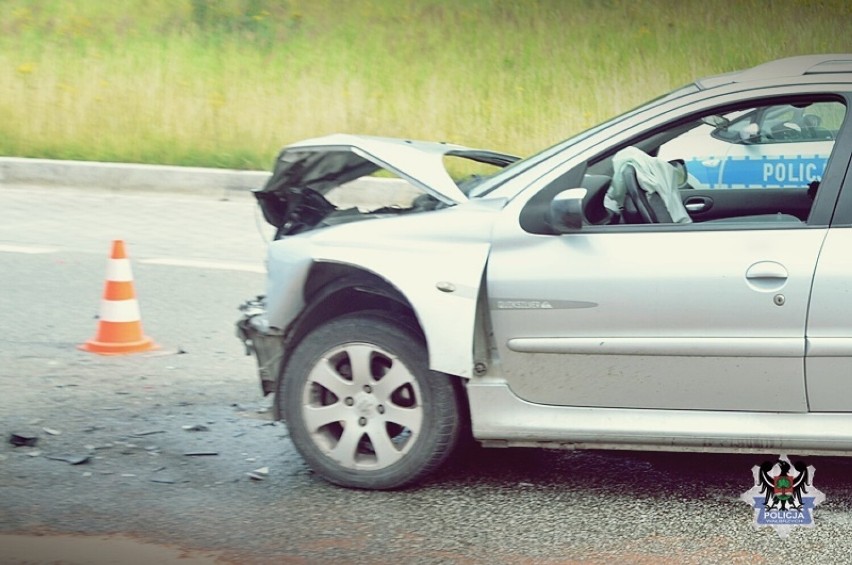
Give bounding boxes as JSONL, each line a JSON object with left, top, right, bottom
{"left": 487, "top": 98, "right": 848, "bottom": 412}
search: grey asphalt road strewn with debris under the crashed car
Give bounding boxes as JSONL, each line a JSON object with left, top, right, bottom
{"left": 0, "top": 187, "right": 852, "bottom": 564}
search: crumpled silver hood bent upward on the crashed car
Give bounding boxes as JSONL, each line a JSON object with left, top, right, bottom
{"left": 255, "top": 134, "right": 518, "bottom": 227}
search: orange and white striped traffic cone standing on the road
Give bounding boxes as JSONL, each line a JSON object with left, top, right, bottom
{"left": 80, "top": 240, "right": 159, "bottom": 355}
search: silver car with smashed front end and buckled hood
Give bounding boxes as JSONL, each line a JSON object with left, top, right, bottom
{"left": 238, "top": 55, "right": 852, "bottom": 489}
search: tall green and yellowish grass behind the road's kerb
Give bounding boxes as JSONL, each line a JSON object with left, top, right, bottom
{"left": 0, "top": 0, "right": 852, "bottom": 169}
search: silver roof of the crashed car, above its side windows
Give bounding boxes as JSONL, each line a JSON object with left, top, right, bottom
{"left": 695, "top": 53, "right": 852, "bottom": 90}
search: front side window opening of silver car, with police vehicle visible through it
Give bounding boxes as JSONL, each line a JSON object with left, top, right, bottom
{"left": 544, "top": 98, "right": 846, "bottom": 229}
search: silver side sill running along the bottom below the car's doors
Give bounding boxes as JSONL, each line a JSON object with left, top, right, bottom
{"left": 467, "top": 379, "right": 852, "bottom": 455}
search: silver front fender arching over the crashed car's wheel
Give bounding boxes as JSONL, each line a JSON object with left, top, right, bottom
{"left": 267, "top": 200, "right": 503, "bottom": 377}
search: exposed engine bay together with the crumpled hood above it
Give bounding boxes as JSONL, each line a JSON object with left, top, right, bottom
{"left": 254, "top": 134, "right": 518, "bottom": 239}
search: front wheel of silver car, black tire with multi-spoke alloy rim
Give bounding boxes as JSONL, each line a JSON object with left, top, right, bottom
{"left": 282, "top": 312, "right": 461, "bottom": 490}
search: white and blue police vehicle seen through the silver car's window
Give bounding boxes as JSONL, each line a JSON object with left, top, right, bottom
{"left": 658, "top": 101, "right": 845, "bottom": 189}
